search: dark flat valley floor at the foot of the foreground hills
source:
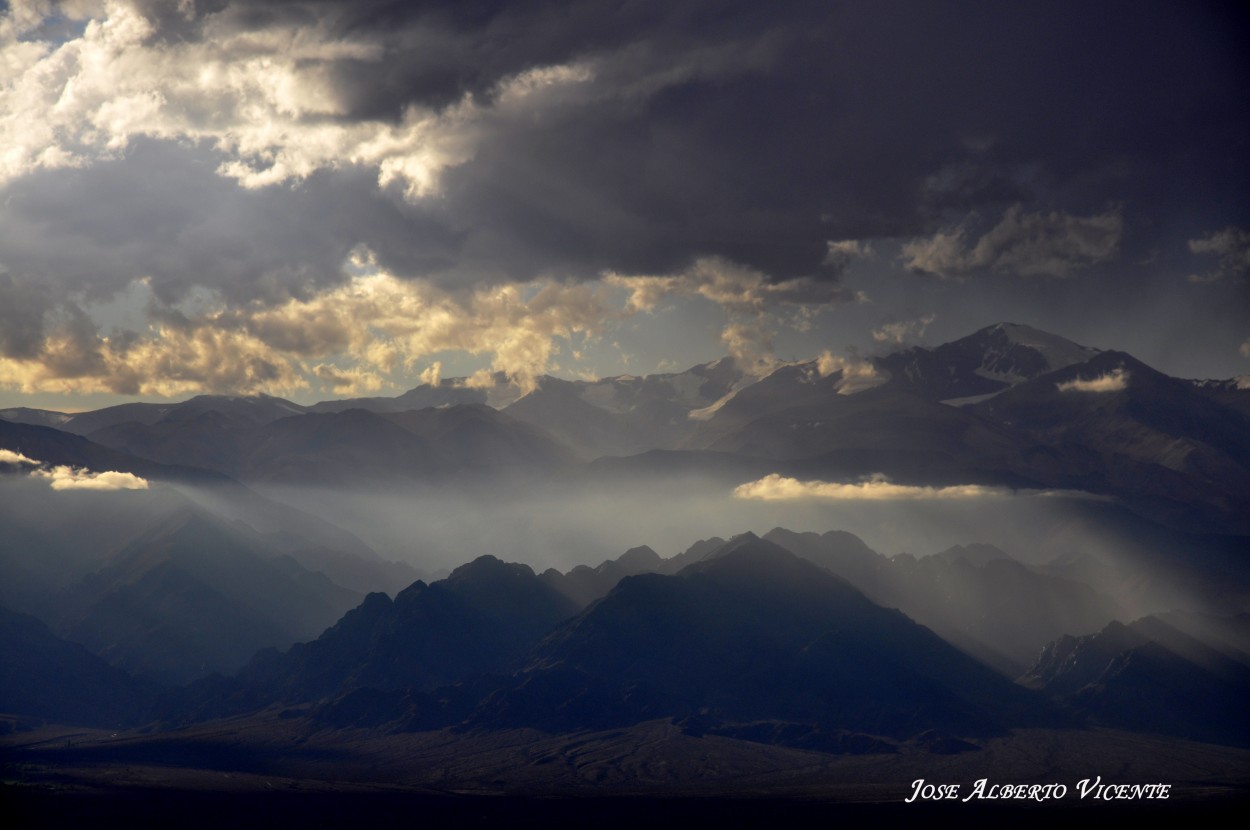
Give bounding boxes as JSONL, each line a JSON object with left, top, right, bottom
{"left": 0, "top": 711, "right": 1250, "bottom": 826}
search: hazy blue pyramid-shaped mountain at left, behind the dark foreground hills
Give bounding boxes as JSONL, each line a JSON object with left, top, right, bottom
{"left": 51, "top": 508, "right": 359, "bottom": 684}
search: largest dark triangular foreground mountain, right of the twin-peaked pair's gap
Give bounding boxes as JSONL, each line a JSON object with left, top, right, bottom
{"left": 473, "top": 538, "right": 1041, "bottom": 738}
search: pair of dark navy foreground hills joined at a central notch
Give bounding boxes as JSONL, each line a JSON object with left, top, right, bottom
{"left": 166, "top": 534, "right": 1055, "bottom": 753}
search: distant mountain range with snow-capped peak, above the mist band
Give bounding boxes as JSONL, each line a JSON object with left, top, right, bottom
{"left": 0, "top": 324, "right": 1250, "bottom": 535}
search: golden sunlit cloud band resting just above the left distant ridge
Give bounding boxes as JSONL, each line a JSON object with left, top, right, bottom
{"left": 0, "top": 251, "right": 624, "bottom": 396}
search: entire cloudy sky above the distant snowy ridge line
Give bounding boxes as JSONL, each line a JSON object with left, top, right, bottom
{"left": 0, "top": 0, "right": 1250, "bottom": 411}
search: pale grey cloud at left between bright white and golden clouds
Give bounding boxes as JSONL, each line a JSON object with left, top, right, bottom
{"left": 0, "top": 140, "right": 454, "bottom": 312}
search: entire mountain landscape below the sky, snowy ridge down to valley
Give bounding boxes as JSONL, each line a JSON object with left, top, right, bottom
{"left": 0, "top": 324, "right": 1250, "bottom": 815}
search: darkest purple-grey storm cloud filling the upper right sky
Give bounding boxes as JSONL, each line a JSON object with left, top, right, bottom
{"left": 290, "top": 3, "right": 1250, "bottom": 279}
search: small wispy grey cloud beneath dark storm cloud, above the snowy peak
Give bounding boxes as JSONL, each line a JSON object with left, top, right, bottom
{"left": 901, "top": 205, "right": 1124, "bottom": 278}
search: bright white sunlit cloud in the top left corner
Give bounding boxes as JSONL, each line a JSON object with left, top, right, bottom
{"left": 0, "top": 0, "right": 593, "bottom": 200}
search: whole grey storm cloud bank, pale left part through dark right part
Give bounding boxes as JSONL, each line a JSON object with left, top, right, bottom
{"left": 4, "top": 0, "right": 1250, "bottom": 298}
